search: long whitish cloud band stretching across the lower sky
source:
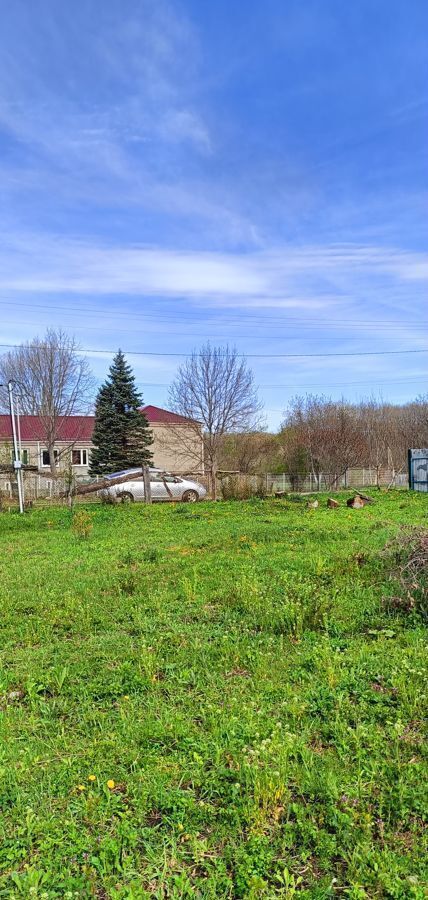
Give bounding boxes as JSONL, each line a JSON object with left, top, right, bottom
{"left": 0, "top": 234, "right": 428, "bottom": 318}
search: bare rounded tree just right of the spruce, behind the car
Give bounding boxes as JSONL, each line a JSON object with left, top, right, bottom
{"left": 169, "top": 343, "right": 262, "bottom": 497}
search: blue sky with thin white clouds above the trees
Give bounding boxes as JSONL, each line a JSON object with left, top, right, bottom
{"left": 0, "top": 0, "right": 428, "bottom": 427}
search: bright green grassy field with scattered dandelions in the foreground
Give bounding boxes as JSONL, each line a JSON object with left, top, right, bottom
{"left": 0, "top": 492, "right": 428, "bottom": 900}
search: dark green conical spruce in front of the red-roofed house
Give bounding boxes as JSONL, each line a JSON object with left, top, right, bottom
{"left": 89, "top": 350, "right": 153, "bottom": 475}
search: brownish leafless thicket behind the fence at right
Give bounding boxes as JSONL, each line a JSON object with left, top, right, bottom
{"left": 221, "top": 394, "right": 428, "bottom": 487}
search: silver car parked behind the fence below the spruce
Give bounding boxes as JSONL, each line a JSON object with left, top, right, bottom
{"left": 101, "top": 469, "right": 207, "bottom": 503}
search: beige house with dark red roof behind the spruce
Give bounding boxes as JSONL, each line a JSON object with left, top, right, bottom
{"left": 0, "top": 406, "right": 204, "bottom": 476}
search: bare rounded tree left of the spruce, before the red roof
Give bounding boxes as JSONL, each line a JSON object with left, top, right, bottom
{"left": 0, "top": 329, "right": 94, "bottom": 475}
